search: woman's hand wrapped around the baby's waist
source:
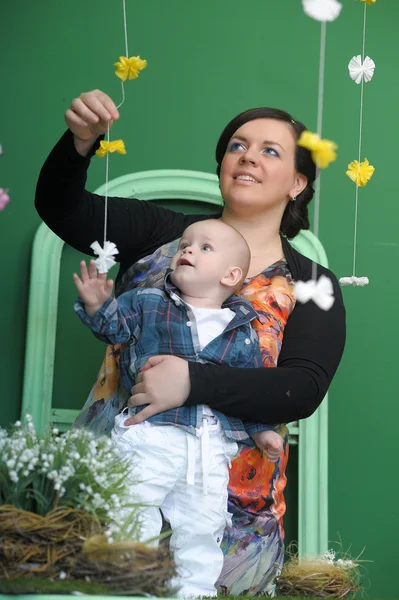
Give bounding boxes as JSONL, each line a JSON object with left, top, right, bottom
{"left": 125, "top": 355, "right": 190, "bottom": 425}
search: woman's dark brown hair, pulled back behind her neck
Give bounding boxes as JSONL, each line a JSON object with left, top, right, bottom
{"left": 216, "top": 108, "right": 316, "bottom": 238}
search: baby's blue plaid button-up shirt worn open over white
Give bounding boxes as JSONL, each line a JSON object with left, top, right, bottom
{"left": 75, "top": 270, "right": 273, "bottom": 446}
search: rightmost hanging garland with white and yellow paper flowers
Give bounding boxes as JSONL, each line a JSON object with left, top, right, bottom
{"left": 339, "top": 0, "right": 377, "bottom": 287}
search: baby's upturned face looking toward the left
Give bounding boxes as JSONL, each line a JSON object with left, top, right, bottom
{"left": 170, "top": 219, "right": 231, "bottom": 296}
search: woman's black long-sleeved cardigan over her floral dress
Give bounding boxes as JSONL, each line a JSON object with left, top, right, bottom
{"left": 35, "top": 131, "right": 345, "bottom": 424}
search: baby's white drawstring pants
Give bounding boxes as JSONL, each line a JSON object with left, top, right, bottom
{"left": 112, "top": 412, "right": 238, "bottom": 598}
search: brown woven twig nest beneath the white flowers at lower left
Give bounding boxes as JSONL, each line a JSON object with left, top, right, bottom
{"left": 0, "top": 505, "right": 176, "bottom": 596}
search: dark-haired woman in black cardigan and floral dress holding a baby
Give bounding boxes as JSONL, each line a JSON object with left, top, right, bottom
{"left": 36, "top": 90, "right": 345, "bottom": 595}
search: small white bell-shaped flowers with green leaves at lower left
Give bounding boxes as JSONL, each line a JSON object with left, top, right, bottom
{"left": 0, "top": 415, "right": 139, "bottom": 543}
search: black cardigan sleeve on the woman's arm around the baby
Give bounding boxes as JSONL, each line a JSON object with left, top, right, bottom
{"left": 187, "top": 272, "right": 345, "bottom": 424}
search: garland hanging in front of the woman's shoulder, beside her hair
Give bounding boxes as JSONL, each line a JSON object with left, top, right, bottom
{"left": 295, "top": 0, "right": 342, "bottom": 310}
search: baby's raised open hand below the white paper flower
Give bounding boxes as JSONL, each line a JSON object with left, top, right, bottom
{"left": 73, "top": 260, "right": 114, "bottom": 317}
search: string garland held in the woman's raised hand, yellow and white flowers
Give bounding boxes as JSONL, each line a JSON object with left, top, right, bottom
{"left": 90, "top": 0, "right": 147, "bottom": 273}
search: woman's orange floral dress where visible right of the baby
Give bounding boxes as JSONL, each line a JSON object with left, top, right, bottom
{"left": 217, "top": 261, "right": 295, "bottom": 596}
